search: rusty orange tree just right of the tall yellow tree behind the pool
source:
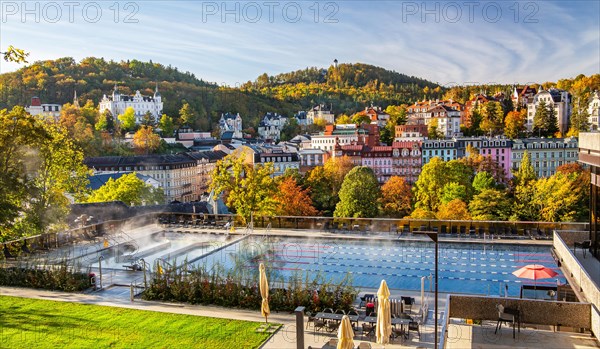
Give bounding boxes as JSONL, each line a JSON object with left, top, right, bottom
{"left": 275, "top": 177, "right": 318, "bottom": 216}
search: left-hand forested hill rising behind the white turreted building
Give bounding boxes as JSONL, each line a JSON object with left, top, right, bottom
{"left": 0, "top": 57, "right": 299, "bottom": 131}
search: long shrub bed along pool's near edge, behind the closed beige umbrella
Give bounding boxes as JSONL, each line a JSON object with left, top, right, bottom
{"left": 142, "top": 260, "right": 358, "bottom": 312}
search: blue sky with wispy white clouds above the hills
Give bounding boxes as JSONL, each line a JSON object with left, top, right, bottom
{"left": 0, "top": 0, "right": 600, "bottom": 85}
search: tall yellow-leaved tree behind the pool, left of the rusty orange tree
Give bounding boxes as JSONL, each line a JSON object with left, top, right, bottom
{"left": 210, "top": 154, "right": 277, "bottom": 223}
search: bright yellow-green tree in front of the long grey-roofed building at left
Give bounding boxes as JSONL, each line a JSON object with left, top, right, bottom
{"left": 87, "top": 172, "right": 165, "bottom": 206}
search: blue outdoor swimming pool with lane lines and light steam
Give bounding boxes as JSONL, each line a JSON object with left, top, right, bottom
{"left": 190, "top": 236, "right": 565, "bottom": 296}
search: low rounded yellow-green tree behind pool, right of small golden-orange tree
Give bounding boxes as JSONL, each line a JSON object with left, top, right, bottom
{"left": 469, "top": 189, "right": 512, "bottom": 221}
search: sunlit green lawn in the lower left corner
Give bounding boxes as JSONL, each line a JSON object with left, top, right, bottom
{"left": 0, "top": 296, "right": 276, "bottom": 349}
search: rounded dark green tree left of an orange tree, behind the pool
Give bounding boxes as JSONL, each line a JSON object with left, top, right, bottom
{"left": 333, "top": 166, "right": 380, "bottom": 218}
